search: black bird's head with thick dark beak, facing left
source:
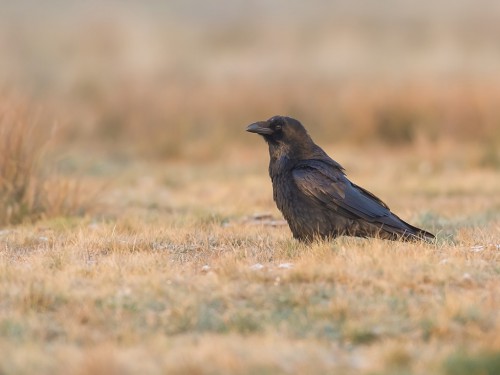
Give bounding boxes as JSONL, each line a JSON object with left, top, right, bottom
{"left": 247, "top": 116, "right": 316, "bottom": 158}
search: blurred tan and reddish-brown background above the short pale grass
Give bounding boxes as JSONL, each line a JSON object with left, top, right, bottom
{"left": 0, "top": 0, "right": 500, "bottom": 164}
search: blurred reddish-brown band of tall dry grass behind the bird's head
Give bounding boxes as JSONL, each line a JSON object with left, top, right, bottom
{"left": 47, "top": 81, "right": 500, "bottom": 162}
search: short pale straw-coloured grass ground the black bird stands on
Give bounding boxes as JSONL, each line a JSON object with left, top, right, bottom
{"left": 0, "top": 145, "right": 500, "bottom": 375}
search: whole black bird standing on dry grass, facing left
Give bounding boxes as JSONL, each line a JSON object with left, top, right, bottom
{"left": 246, "top": 116, "right": 434, "bottom": 242}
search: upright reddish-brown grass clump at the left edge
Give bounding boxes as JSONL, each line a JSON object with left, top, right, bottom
{"left": 0, "top": 100, "right": 91, "bottom": 225}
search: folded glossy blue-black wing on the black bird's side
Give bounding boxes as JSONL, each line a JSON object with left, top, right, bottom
{"left": 292, "top": 160, "right": 392, "bottom": 225}
